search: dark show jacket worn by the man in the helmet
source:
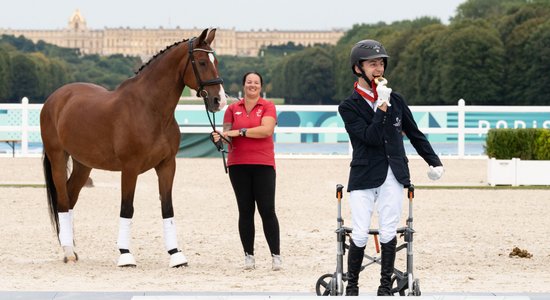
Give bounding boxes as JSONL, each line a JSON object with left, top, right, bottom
{"left": 338, "top": 91, "right": 442, "bottom": 192}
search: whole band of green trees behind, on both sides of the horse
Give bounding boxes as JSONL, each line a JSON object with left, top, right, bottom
{"left": 0, "top": 0, "right": 550, "bottom": 105}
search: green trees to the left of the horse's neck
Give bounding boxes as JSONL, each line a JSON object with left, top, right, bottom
{"left": 0, "top": 35, "right": 141, "bottom": 103}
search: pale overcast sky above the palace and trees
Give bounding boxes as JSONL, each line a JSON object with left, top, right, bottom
{"left": 0, "top": 0, "right": 466, "bottom": 31}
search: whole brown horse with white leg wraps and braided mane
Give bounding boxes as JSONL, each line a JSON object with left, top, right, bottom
{"left": 40, "top": 29, "right": 226, "bottom": 267}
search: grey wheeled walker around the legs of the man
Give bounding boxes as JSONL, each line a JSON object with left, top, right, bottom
{"left": 315, "top": 184, "right": 421, "bottom": 296}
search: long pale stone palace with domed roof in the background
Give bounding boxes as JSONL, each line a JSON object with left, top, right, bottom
{"left": 0, "top": 10, "right": 344, "bottom": 61}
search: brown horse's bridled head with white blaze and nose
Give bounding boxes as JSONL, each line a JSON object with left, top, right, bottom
{"left": 184, "top": 29, "right": 227, "bottom": 112}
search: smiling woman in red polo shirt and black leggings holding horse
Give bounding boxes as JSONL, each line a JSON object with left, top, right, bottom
{"left": 213, "top": 72, "right": 282, "bottom": 271}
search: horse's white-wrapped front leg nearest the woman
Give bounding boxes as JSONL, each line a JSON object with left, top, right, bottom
{"left": 155, "top": 157, "right": 187, "bottom": 268}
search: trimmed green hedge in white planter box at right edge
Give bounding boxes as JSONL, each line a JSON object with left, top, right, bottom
{"left": 484, "top": 128, "right": 550, "bottom": 160}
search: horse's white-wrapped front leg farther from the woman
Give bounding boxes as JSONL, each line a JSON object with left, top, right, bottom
{"left": 117, "top": 170, "right": 138, "bottom": 267}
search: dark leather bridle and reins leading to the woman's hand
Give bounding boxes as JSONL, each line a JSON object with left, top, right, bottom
{"left": 183, "top": 38, "right": 231, "bottom": 174}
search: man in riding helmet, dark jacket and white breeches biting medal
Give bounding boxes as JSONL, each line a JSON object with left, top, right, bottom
{"left": 338, "top": 40, "right": 444, "bottom": 296}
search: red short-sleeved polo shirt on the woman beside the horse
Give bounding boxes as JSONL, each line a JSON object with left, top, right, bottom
{"left": 223, "top": 98, "right": 277, "bottom": 167}
